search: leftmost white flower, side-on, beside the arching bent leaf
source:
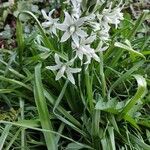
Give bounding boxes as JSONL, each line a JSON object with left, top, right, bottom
{"left": 41, "top": 9, "right": 59, "bottom": 36}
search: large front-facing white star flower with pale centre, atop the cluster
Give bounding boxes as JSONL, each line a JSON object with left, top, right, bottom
{"left": 57, "top": 12, "right": 87, "bottom": 42}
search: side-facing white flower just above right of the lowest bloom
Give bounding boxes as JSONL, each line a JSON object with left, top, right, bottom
{"left": 72, "top": 36, "right": 100, "bottom": 64}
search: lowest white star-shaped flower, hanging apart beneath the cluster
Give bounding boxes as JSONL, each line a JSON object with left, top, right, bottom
{"left": 46, "top": 54, "right": 81, "bottom": 84}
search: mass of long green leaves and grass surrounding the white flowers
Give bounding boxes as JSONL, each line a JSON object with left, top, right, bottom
{"left": 0, "top": 1, "right": 150, "bottom": 150}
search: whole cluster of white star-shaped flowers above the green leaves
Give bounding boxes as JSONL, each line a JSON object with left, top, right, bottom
{"left": 42, "top": 0, "right": 123, "bottom": 84}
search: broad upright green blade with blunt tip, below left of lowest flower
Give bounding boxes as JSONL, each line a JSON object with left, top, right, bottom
{"left": 34, "top": 64, "right": 57, "bottom": 150}
